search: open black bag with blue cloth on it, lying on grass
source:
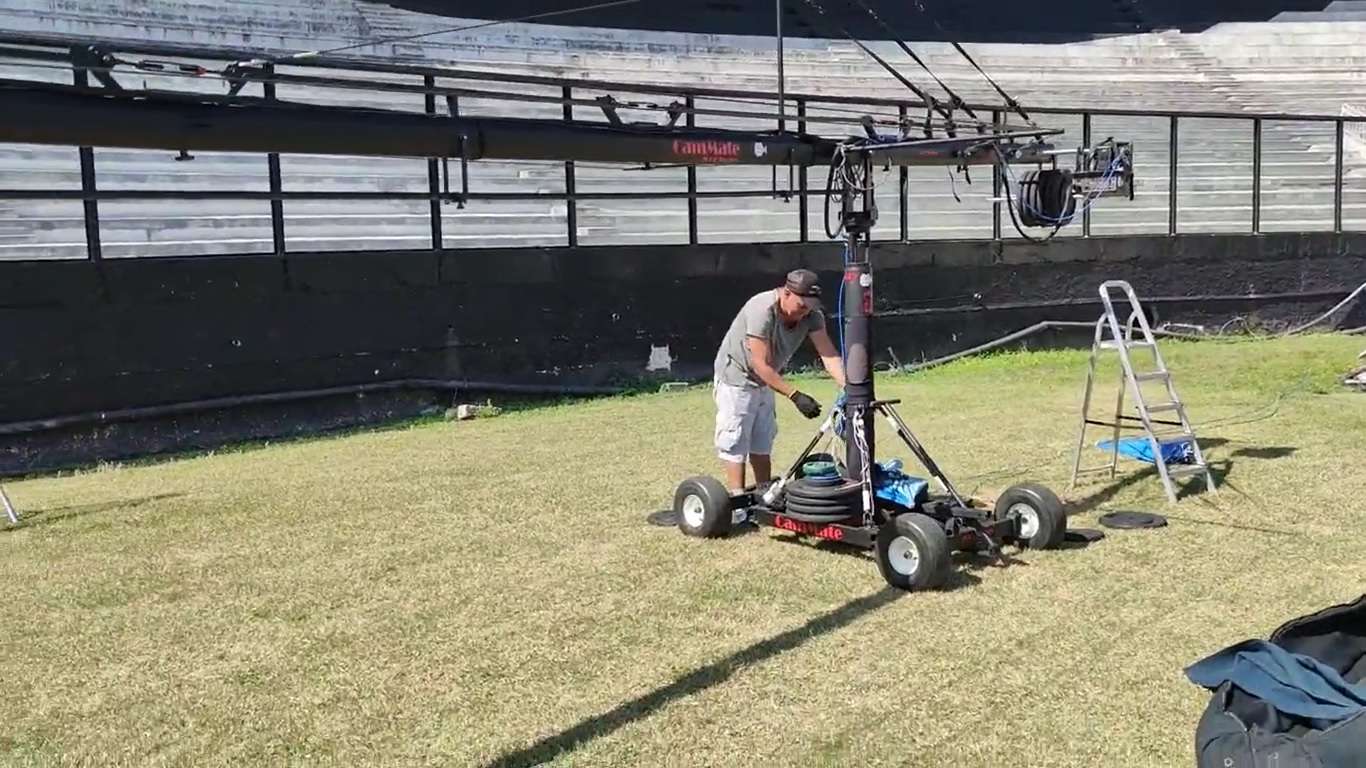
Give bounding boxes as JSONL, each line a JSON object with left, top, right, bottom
{"left": 1187, "top": 594, "right": 1366, "bottom": 768}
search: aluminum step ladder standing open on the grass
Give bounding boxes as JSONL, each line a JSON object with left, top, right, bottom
{"left": 1070, "top": 280, "right": 1216, "bottom": 504}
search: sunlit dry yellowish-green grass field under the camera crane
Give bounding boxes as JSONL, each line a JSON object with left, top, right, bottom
{"left": 0, "top": 336, "right": 1366, "bottom": 767}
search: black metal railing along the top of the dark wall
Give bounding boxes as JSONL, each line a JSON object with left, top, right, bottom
{"left": 0, "top": 33, "right": 1366, "bottom": 261}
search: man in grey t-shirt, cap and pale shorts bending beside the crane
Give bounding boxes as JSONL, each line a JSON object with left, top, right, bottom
{"left": 713, "top": 269, "right": 844, "bottom": 491}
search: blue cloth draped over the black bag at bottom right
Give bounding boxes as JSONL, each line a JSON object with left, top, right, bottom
{"left": 1186, "top": 640, "right": 1366, "bottom": 723}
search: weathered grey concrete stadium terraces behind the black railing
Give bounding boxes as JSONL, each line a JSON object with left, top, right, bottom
{"left": 0, "top": 0, "right": 1366, "bottom": 258}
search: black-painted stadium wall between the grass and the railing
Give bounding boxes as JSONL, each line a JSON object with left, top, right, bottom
{"left": 0, "top": 234, "right": 1366, "bottom": 473}
